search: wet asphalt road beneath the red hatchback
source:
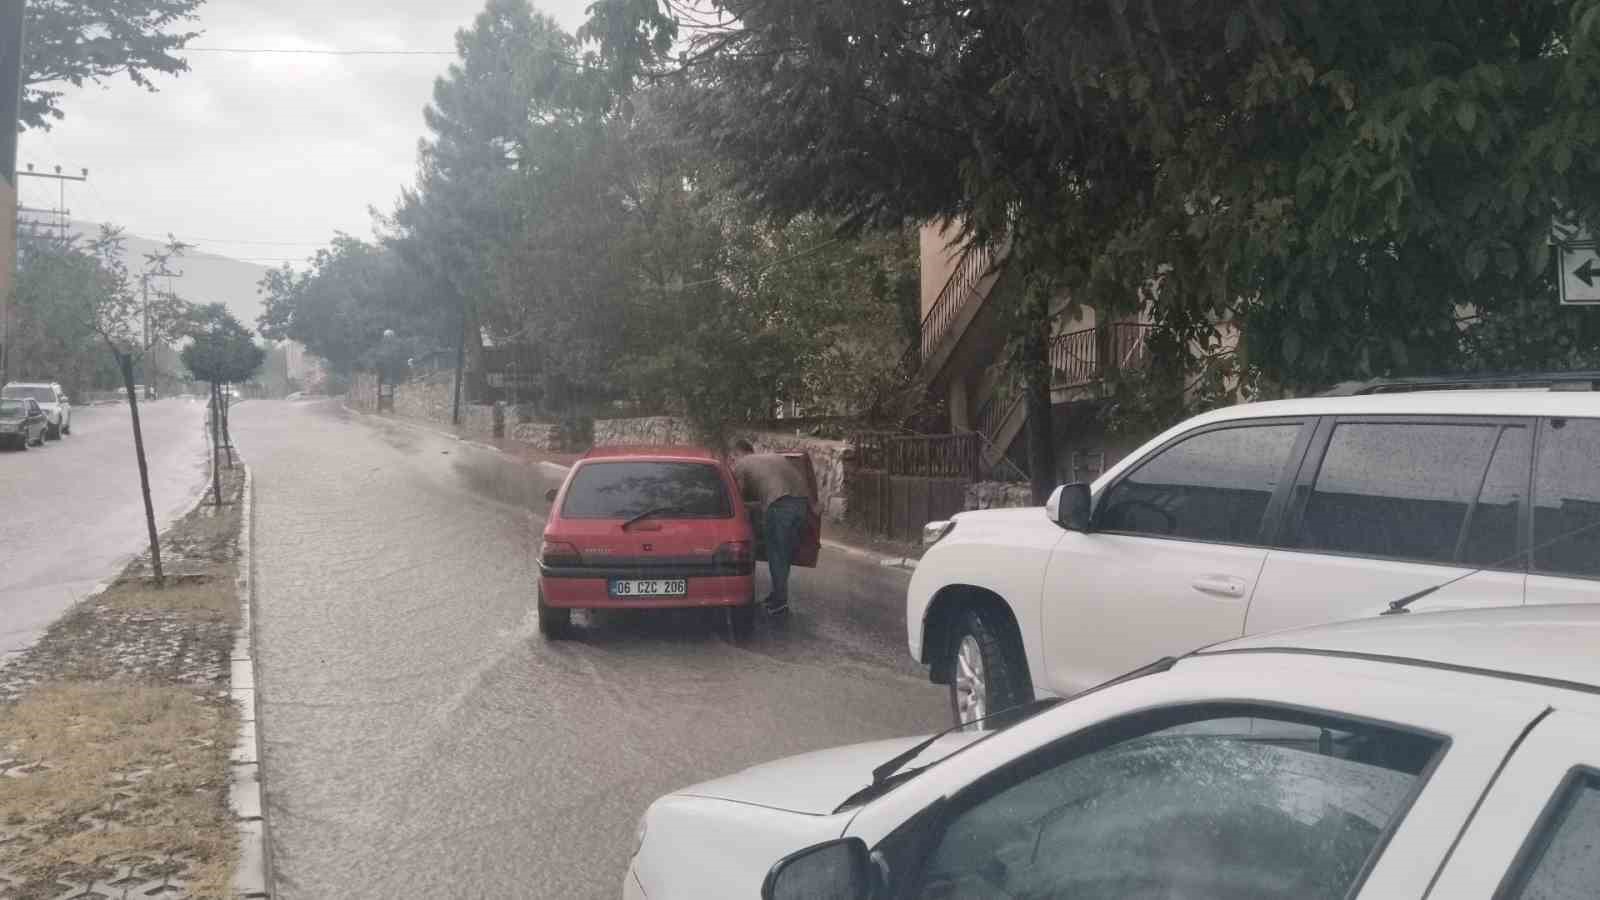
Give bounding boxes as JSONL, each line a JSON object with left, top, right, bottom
{"left": 234, "top": 400, "right": 949, "bottom": 898}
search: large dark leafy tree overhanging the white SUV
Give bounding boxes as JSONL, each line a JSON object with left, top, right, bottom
{"left": 582, "top": 0, "right": 1600, "bottom": 490}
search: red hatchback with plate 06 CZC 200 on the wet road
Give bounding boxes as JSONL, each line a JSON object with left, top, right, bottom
{"left": 538, "top": 447, "right": 816, "bottom": 637}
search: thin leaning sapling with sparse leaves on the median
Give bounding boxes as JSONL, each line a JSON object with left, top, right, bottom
{"left": 84, "top": 226, "right": 189, "bottom": 583}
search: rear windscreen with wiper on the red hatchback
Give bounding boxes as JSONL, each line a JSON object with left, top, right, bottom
{"left": 562, "top": 460, "right": 733, "bottom": 519}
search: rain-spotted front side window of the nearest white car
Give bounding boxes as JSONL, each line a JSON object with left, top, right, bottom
{"left": 909, "top": 709, "right": 1442, "bottom": 900}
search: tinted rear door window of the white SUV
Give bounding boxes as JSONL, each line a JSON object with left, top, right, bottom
{"left": 1288, "top": 423, "right": 1528, "bottom": 565}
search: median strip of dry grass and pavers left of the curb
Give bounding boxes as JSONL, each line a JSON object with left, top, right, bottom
{"left": 0, "top": 458, "right": 243, "bottom": 900}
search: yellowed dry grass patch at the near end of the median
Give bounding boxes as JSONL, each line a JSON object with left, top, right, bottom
{"left": 0, "top": 682, "right": 238, "bottom": 900}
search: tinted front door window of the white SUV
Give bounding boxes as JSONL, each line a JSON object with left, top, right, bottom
{"left": 1098, "top": 423, "right": 1301, "bottom": 544}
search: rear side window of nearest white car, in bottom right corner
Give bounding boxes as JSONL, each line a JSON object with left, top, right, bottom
{"left": 1496, "top": 770, "right": 1600, "bottom": 900}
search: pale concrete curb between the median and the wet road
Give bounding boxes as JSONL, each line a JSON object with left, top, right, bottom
{"left": 228, "top": 463, "right": 272, "bottom": 898}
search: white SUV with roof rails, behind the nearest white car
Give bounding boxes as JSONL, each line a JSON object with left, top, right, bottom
{"left": 906, "top": 373, "right": 1600, "bottom": 722}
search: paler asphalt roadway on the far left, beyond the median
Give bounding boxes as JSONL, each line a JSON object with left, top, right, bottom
{"left": 0, "top": 397, "right": 206, "bottom": 658}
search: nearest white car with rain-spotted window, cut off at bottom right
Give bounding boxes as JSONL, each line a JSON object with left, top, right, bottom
{"left": 622, "top": 605, "right": 1600, "bottom": 900}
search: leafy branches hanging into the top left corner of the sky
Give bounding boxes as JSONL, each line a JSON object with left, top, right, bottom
{"left": 21, "top": 0, "right": 205, "bottom": 128}
